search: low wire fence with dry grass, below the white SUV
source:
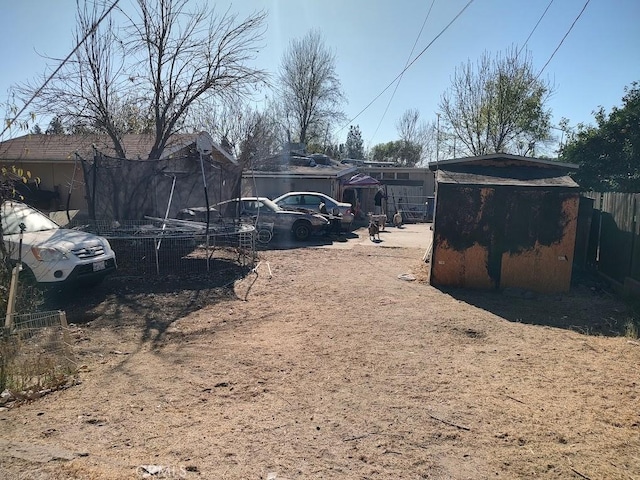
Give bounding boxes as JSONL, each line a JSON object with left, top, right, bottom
{"left": 0, "top": 311, "right": 77, "bottom": 392}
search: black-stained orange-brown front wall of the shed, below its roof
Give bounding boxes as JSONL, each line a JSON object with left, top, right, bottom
{"left": 431, "top": 184, "right": 579, "bottom": 292}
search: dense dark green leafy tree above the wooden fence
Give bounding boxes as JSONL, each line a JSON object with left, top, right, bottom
{"left": 560, "top": 81, "right": 640, "bottom": 193}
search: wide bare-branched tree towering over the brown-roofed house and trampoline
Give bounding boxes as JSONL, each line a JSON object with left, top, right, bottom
{"left": 16, "top": 0, "right": 266, "bottom": 159}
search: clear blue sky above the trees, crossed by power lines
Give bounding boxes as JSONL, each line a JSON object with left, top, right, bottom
{"left": 0, "top": 0, "right": 640, "bottom": 153}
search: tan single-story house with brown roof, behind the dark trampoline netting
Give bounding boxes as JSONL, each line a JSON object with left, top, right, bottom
{"left": 0, "top": 132, "right": 240, "bottom": 220}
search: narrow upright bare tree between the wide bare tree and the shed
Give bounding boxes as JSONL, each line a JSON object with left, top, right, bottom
{"left": 279, "top": 30, "right": 345, "bottom": 144}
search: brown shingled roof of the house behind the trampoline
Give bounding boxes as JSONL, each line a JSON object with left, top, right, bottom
{"left": 0, "top": 132, "right": 237, "bottom": 164}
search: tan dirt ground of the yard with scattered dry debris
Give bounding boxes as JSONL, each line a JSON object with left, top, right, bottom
{"left": 0, "top": 225, "right": 640, "bottom": 480}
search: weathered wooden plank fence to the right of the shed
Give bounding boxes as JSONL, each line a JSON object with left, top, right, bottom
{"left": 576, "top": 192, "right": 640, "bottom": 292}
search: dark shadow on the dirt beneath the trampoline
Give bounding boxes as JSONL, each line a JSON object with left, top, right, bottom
{"left": 44, "top": 260, "right": 251, "bottom": 342}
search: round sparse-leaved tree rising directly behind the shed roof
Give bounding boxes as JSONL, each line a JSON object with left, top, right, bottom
{"left": 440, "top": 48, "right": 552, "bottom": 155}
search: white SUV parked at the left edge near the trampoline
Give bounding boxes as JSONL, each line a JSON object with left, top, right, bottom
{"left": 0, "top": 200, "right": 116, "bottom": 285}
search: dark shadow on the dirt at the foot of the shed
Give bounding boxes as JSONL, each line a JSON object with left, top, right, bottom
{"left": 442, "top": 276, "right": 637, "bottom": 336}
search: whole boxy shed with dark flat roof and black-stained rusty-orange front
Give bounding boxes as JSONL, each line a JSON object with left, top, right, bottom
{"left": 429, "top": 154, "right": 579, "bottom": 293}
